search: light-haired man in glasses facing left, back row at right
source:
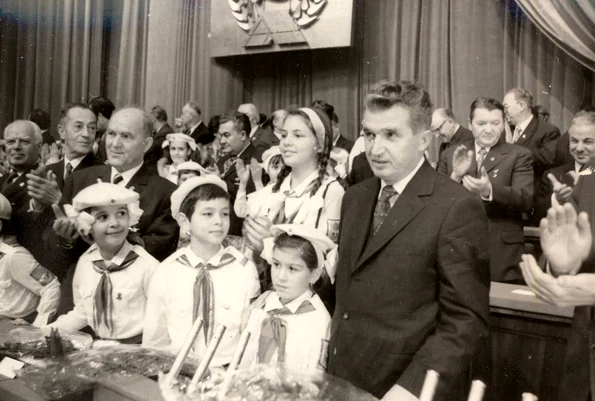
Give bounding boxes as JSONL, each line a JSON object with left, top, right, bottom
{"left": 502, "top": 88, "right": 560, "bottom": 183}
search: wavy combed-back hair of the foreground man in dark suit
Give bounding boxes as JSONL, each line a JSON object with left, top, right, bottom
{"left": 364, "top": 81, "right": 432, "bottom": 134}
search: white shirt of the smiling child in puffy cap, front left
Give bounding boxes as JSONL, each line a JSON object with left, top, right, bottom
{"left": 49, "top": 241, "right": 159, "bottom": 340}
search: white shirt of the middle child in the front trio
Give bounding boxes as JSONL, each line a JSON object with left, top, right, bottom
{"left": 143, "top": 246, "right": 260, "bottom": 366}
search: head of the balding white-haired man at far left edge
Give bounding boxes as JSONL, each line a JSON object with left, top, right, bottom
{"left": 4, "top": 120, "right": 43, "bottom": 173}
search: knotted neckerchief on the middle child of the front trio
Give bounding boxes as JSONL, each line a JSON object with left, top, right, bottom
{"left": 177, "top": 253, "right": 235, "bottom": 344}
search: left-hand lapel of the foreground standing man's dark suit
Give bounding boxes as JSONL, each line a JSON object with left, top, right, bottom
{"left": 342, "top": 178, "right": 380, "bottom": 271}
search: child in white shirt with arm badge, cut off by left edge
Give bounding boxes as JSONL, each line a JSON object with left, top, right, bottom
{"left": 0, "top": 194, "right": 60, "bottom": 327}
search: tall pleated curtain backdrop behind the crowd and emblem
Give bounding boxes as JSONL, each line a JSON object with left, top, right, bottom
{"left": 0, "top": 0, "right": 595, "bottom": 162}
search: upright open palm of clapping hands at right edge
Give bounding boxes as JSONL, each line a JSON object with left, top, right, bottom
{"left": 539, "top": 198, "right": 592, "bottom": 275}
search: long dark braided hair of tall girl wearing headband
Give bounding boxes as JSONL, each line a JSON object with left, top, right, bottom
{"left": 273, "top": 107, "right": 333, "bottom": 196}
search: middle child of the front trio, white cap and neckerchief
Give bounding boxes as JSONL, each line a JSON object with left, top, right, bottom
{"left": 143, "top": 174, "right": 260, "bottom": 366}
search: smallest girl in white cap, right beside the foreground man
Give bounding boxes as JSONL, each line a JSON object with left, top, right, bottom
{"left": 242, "top": 224, "right": 337, "bottom": 372}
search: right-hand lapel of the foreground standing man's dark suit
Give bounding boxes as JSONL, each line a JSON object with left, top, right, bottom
{"left": 355, "top": 162, "right": 436, "bottom": 270}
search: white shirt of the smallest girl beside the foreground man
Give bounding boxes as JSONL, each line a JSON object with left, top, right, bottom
{"left": 240, "top": 290, "right": 331, "bottom": 372}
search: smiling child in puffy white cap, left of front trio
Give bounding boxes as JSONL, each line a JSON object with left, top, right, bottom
{"left": 49, "top": 182, "right": 159, "bottom": 344}
